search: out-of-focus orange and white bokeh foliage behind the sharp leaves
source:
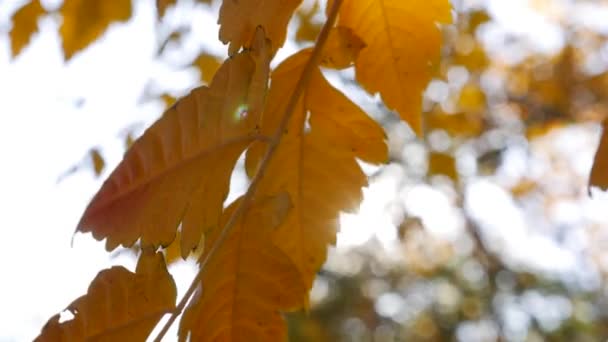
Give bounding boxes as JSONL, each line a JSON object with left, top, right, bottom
{"left": 12, "top": 0, "right": 608, "bottom": 341}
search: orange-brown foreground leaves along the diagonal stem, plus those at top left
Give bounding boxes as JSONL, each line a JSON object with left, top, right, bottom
{"left": 11, "top": 0, "right": 451, "bottom": 341}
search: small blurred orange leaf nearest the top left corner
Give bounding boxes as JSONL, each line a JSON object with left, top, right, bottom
{"left": 10, "top": 0, "right": 46, "bottom": 57}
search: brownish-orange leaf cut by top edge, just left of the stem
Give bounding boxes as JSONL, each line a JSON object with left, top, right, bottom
{"left": 219, "top": 0, "right": 302, "bottom": 56}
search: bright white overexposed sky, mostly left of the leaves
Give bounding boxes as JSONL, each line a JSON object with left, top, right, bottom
{"left": 0, "top": 0, "right": 605, "bottom": 341}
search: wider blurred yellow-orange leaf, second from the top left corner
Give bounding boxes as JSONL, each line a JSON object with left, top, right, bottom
{"left": 59, "top": 0, "right": 132, "bottom": 60}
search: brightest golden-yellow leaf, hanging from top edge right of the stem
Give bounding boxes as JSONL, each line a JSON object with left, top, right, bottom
{"left": 339, "top": 0, "right": 451, "bottom": 134}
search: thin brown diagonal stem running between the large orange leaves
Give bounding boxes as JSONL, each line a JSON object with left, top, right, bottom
{"left": 154, "top": 0, "right": 343, "bottom": 342}
